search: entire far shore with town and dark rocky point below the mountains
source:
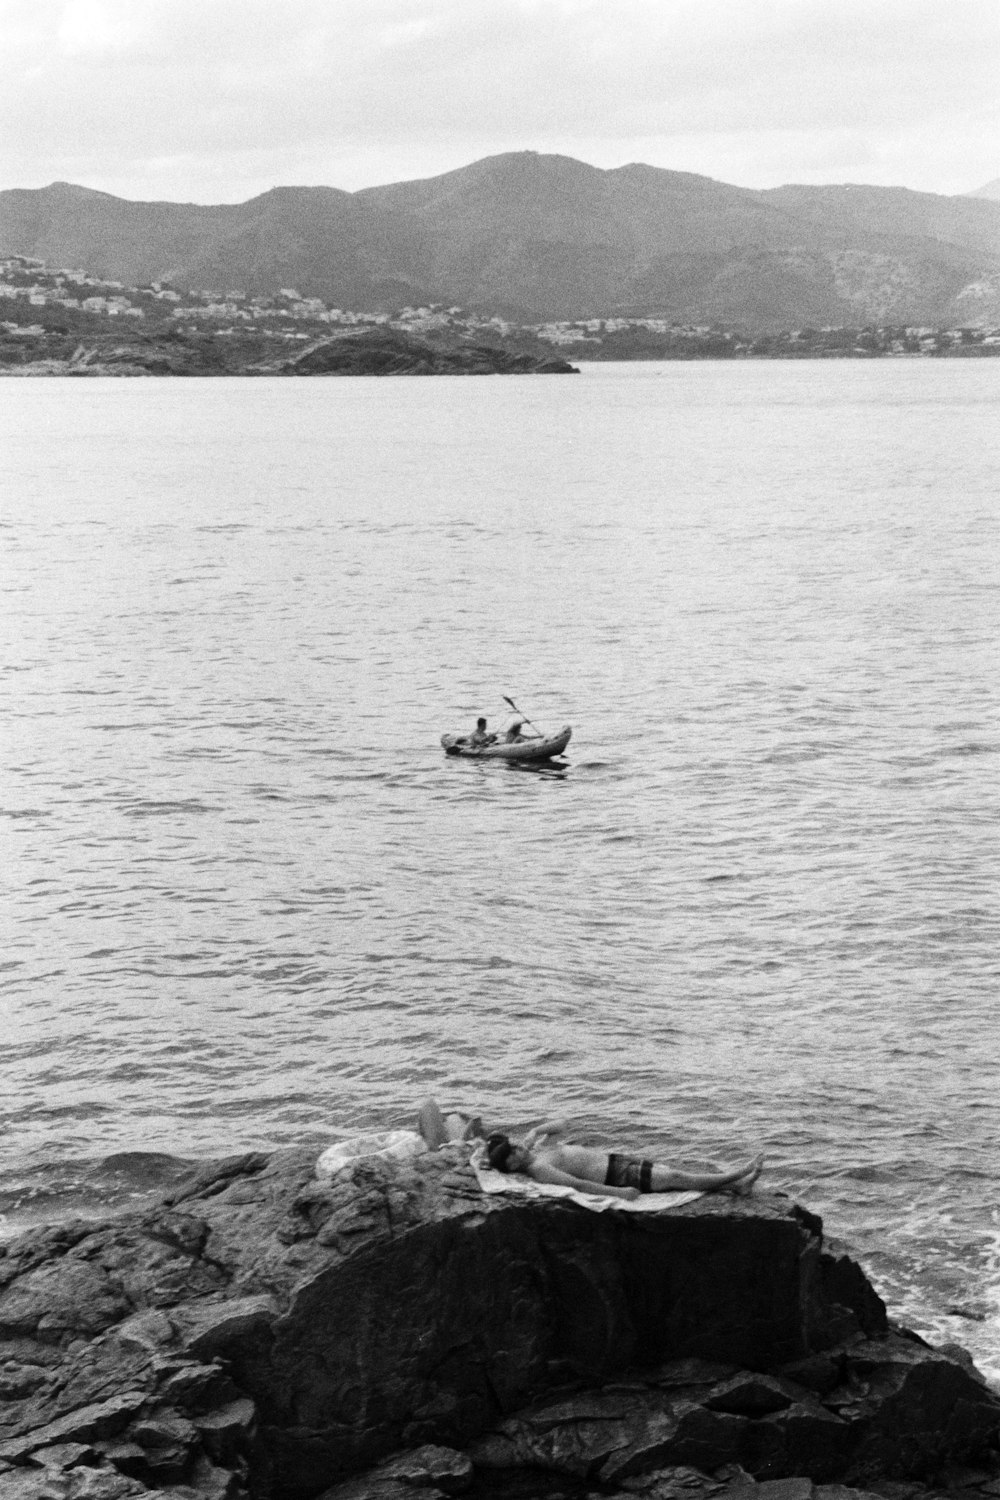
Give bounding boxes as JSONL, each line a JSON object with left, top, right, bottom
{"left": 0, "top": 255, "right": 1000, "bottom": 375}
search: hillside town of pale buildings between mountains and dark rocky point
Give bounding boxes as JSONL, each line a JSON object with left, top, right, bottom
{"left": 0, "top": 255, "right": 1000, "bottom": 369}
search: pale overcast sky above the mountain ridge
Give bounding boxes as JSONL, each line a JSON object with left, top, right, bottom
{"left": 0, "top": 0, "right": 1000, "bottom": 203}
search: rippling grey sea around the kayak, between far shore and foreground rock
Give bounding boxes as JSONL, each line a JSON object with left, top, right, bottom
{"left": 0, "top": 360, "right": 1000, "bottom": 1376}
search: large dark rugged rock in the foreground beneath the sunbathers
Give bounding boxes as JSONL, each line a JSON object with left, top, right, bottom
{"left": 0, "top": 1145, "right": 1000, "bottom": 1500}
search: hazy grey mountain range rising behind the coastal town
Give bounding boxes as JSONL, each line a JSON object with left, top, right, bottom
{"left": 0, "top": 152, "right": 1000, "bottom": 332}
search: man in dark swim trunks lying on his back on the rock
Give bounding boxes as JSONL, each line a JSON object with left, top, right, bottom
{"left": 486, "top": 1121, "right": 763, "bottom": 1199}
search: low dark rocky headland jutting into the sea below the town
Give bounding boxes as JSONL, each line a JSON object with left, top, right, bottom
{"left": 0, "top": 327, "right": 577, "bottom": 377}
